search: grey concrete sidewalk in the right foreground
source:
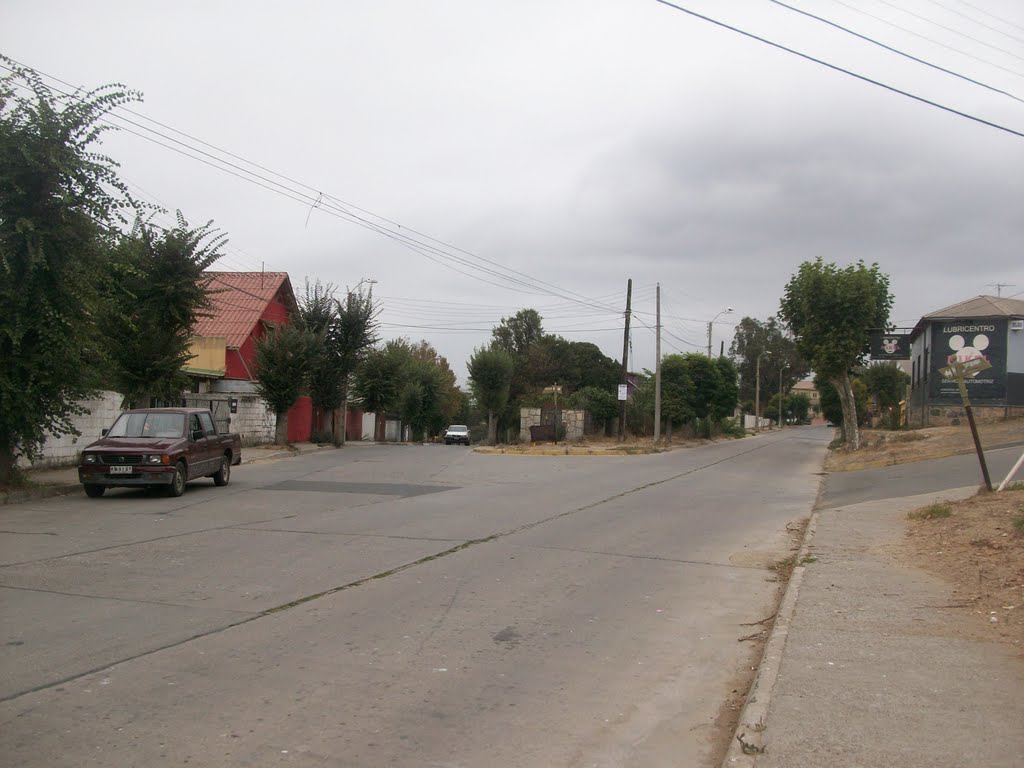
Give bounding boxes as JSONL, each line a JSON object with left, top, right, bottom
{"left": 723, "top": 486, "right": 1024, "bottom": 768}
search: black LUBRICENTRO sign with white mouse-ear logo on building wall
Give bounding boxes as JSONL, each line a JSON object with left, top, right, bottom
{"left": 928, "top": 317, "right": 1007, "bottom": 402}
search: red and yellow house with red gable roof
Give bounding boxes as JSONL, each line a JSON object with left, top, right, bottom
{"left": 185, "top": 271, "right": 312, "bottom": 443}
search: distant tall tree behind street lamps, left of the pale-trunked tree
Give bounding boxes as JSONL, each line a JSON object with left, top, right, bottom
{"left": 729, "top": 317, "right": 810, "bottom": 413}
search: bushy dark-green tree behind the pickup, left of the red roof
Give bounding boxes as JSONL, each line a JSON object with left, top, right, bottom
{"left": 97, "top": 211, "right": 226, "bottom": 407}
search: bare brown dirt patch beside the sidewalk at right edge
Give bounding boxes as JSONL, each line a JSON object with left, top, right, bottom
{"left": 905, "top": 484, "right": 1024, "bottom": 653}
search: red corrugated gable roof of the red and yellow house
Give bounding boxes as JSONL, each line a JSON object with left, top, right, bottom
{"left": 194, "top": 272, "right": 295, "bottom": 349}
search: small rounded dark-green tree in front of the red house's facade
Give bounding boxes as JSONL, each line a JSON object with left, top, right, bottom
{"left": 254, "top": 325, "right": 316, "bottom": 445}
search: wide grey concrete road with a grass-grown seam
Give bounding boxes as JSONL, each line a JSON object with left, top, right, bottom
{"left": 0, "top": 427, "right": 831, "bottom": 768}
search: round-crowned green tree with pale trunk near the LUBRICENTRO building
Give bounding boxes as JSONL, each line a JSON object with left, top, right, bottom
{"left": 779, "top": 258, "right": 893, "bottom": 451}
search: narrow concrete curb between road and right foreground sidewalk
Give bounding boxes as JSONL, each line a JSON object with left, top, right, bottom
{"left": 722, "top": 510, "right": 818, "bottom": 768}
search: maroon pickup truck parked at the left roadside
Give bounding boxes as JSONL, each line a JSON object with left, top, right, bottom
{"left": 78, "top": 408, "right": 242, "bottom": 498}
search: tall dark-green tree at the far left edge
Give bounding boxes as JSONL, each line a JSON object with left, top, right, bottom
{"left": 0, "top": 56, "right": 139, "bottom": 484}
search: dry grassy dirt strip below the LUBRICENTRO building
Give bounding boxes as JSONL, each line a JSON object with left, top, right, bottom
{"left": 825, "top": 419, "right": 1024, "bottom": 472}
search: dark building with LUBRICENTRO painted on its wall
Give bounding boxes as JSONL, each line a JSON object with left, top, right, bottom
{"left": 907, "top": 296, "right": 1024, "bottom": 426}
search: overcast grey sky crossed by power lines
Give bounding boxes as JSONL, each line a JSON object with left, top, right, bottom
{"left": 0, "top": 0, "right": 1024, "bottom": 381}
